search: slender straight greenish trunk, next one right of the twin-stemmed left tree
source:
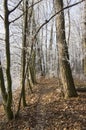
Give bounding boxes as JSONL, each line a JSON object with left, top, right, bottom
{"left": 22, "top": 0, "right": 28, "bottom": 106}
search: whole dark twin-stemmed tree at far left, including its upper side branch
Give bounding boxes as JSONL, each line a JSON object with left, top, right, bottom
{"left": 0, "top": 0, "right": 22, "bottom": 120}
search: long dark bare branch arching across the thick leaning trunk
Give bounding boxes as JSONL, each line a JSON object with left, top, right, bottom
{"left": 33, "top": 0, "right": 85, "bottom": 39}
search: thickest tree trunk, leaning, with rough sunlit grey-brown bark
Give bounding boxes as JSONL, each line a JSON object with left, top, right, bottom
{"left": 55, "top": 0, "right": 77, "bottom": 98}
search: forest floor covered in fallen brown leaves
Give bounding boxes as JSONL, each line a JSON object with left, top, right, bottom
{"left": 0, "top": 78, "right": 86, "bottom": 130}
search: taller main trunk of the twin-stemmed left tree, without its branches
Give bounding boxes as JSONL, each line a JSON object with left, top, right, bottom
{"left": 4, "top": 0, "right": 13, "bottom": 120}
